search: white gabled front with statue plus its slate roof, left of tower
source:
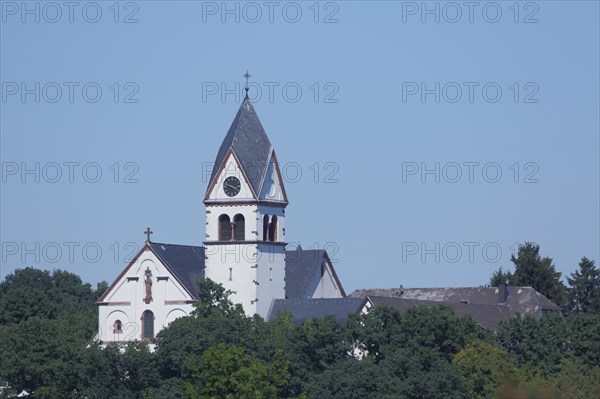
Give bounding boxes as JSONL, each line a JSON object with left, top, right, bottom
{"left": 97, "top": 242, "right": 204, "bottom": 342}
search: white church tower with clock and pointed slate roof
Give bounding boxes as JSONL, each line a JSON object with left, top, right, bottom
{"left": 204, "top": 96, "right": 288, "bottom": 317}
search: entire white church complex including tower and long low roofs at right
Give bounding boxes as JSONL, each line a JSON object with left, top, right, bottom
{"left": 97, "top": 86, "right": 560, "bottom": 344}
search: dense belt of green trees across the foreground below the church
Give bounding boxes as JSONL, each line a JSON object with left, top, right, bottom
{"left": 0, "top": 270, "right": 600, "bottom": 399}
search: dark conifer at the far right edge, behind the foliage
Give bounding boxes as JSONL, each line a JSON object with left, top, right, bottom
{"left": 567, "top": 257, "right": 600, "bottom": 314}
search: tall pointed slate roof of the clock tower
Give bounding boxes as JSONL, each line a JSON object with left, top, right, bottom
{"left": 207, "top": 98, "right": 273, "bottom": 196}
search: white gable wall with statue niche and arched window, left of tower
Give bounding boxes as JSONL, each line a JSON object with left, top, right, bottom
{"left": 98, "top": 247, "right": 194, "bottom": 343}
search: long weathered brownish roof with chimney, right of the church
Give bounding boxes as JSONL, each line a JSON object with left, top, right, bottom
{"left": 349, "top": 287, "right": 561, "bottom": 315}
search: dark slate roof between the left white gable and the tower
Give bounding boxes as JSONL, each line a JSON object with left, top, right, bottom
{"left": 148, "top": 242, "right": 204, "bottom": 300}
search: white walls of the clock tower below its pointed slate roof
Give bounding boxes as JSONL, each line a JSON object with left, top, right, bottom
{"left": 204, "top": 151, "right": 286, "bottom": 317}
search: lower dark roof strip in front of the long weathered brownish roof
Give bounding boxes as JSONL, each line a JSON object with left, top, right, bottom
{"left": 368, "top": 296, "right": 514, "bottom": 331}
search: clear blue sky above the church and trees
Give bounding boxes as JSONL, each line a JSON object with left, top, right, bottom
{"left": 0, "top": 1, "right": 600, "bottom": 292}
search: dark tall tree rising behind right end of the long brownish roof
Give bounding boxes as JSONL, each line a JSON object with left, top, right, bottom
{"left": 510, "top": 242, "right": 566, "bottom": 306}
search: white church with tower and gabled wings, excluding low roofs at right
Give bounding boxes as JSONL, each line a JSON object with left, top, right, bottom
{"left": 97, "top": 91, "right": 346, "bottom": 343}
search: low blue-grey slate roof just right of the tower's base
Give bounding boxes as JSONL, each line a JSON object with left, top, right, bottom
{"left": 266, "top": 298, "right": 365, "bottom": 324}
